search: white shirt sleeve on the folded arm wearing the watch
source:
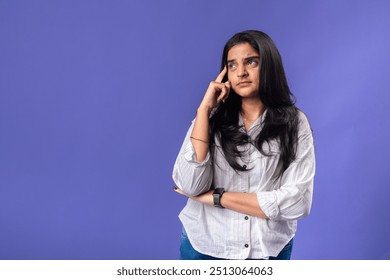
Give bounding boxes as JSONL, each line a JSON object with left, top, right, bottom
{"left": 257, "top": 113, "right": 315, "bottom": 220}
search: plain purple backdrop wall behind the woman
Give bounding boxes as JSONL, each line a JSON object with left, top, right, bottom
{"left": 0, "top": 0, "right": 390, "bottom": 259}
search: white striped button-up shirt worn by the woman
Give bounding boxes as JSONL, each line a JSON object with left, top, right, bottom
{"left": 173, "top": 111, "right": 315, "bottom": 259}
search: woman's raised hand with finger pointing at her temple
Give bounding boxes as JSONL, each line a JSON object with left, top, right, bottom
{"left": 199, "top": 66, "right": 230, "bottom": 111}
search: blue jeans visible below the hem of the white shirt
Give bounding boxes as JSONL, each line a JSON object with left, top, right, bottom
{"left": 180, "top": 228, "right": 293, "bottom": 260}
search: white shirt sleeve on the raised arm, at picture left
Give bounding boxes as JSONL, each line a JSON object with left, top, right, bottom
{"left": 172, "top": 121, "right": 213, "bottom": 196}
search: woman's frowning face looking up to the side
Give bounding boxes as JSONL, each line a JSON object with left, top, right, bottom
{"left": 227, "top": 43, "right": 260, "bottom": 98}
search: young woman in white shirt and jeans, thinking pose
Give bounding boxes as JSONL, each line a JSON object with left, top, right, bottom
{"left": 173, "top": 30, "right": 315, "bottom": 259}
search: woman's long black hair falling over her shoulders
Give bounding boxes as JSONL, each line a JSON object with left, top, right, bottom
{"left": 210, "top": 30, "right": 299, "bottom": 178}
